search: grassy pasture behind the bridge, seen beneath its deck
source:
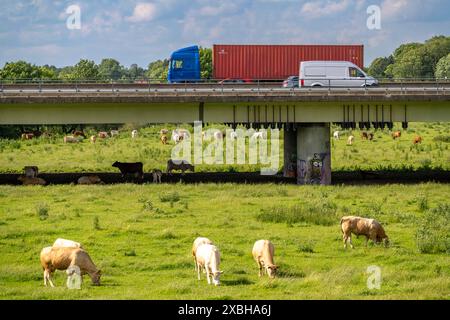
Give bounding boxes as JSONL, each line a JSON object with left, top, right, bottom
{"left": 0, "top": 123, "right": 450, "bottom": 173}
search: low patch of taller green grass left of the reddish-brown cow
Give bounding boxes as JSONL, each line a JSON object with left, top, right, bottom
{"left": 256, "top": 201, "right": 337, "bottom": 226}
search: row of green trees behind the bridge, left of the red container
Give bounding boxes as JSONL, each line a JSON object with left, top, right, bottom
{"left": 0, "top": 48, "right": 212, "bottom": 81}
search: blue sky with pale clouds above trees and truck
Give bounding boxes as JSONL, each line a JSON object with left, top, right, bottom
{"left": 0, "top": 0, "right": 450, "bottom": 68}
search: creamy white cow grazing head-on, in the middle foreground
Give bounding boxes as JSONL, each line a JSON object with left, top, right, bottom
{"left": 195, "top": 244, "right": 223, "bottom": 286}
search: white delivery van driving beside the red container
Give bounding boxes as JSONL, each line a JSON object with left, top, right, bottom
{"left": 299, "top": 61, "right": 378, "bottom": 87}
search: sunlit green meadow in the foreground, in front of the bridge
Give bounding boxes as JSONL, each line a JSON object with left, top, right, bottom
{"left": 0, "top": 184, "right": 450, "bottom": 299}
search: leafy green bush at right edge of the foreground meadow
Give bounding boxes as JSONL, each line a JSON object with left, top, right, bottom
{"left": 416, "top": 204, "right": 450, "bottom": 253}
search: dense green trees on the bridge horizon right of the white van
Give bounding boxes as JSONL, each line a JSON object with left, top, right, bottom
{"left": 367, "top": 36, "right": 450, "bottom": 79}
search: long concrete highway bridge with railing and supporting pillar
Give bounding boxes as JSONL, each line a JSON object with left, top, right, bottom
{"left": 0, "top": 82, "right": 450, "bottom": 184}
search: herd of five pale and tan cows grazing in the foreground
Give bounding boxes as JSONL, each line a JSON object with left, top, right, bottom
{"left": 40, "top": 216, "right": 389, "bottom": 287}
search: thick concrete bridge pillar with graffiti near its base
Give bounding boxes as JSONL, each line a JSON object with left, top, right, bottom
{"left": 297, "top": 123, "right": 331, "bottom": 185}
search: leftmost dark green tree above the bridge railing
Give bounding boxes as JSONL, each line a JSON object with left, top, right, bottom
{"left": 0, "top": 60, "right": 55, "bottom": 80}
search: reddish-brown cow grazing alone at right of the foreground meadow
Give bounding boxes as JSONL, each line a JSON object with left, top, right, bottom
{"left": 341, "top": 216, "right": 389, "bottom": 248}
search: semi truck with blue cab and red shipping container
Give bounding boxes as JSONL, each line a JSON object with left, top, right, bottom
{"left": 168, "top": 44, "right": 364, "bottom": 83}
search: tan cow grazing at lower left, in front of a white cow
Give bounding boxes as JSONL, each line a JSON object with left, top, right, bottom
{"left": 40, "top": 247, "right": 101, "bottom": 287}
